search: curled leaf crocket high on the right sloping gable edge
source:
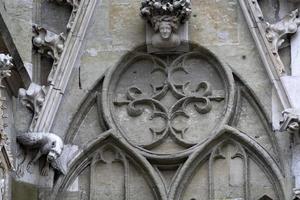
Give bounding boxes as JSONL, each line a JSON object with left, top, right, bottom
{"left": 266, "top": 9, "right": 300, "bottom": 75}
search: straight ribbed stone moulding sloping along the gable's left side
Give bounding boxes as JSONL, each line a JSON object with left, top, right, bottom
{"left": 34, "top": 0, "right": 97, "bottom": 132}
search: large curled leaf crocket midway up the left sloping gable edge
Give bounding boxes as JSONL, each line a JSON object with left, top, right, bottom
{"left": 32, "top": 25, "right": 66, "bottom": 82}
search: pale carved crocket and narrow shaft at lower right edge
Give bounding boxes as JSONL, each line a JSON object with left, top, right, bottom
{"left": 280, "top": 108, "right": 300, "bottom": 199}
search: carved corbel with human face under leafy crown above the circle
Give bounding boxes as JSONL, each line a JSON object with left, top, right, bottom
{"left": 141, "top": 0, "right": 192, "bottom": 48}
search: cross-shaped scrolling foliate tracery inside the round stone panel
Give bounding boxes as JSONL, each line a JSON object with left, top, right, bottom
{"left": 113, "top": 53, "right": 225, "bottom": 149}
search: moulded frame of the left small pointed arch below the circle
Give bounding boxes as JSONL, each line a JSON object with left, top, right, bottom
{"left": 51, "top": 130, "right": 167, "bottom": 200}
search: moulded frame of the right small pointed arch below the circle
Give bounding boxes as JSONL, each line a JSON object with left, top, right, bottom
{"left": 169, "top": 126, "right": 285, "bottom": 200}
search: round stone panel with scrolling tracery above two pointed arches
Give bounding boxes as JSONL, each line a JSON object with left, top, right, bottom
{"left": 103, "top": 49, "right": 234, "bottom": 156}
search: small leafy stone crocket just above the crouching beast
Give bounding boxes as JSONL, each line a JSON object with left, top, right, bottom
{"left": 19, "top": 83, "right": 46, "bottom": 128}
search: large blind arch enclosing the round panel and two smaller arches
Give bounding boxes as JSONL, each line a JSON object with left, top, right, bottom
{"left": 52, "top": 44, "right": 285, "bottom": 200}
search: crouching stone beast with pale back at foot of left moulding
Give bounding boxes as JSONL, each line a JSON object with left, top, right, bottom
{"left": 17, "top": 132, "right": 64, "bottom": 176}
